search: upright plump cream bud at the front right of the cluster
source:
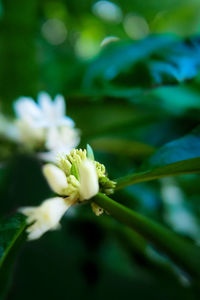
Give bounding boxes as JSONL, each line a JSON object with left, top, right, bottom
{"left": 79, "top": 159, "right": 99, "bottom": 200}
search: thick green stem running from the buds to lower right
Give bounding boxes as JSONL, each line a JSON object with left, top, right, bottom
{"left": 93, "top": 193, "right": 200, "bottom": 278}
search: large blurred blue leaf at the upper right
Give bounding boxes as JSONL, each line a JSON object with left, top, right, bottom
{"left": 83, "top": 35, "right": 200, "bottom": 93}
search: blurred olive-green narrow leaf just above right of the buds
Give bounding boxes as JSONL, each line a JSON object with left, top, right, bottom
{"left": 90, "top": 137, "right": 155, "bottom": 158}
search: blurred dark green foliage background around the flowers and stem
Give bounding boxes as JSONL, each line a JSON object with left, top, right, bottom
{"left": 0, "top": 0, "right": 200, "bottom": 300}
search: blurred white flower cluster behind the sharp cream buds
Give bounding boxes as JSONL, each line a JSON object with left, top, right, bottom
{"left": 14, "top": 92, "right": 80, "bottom": 162}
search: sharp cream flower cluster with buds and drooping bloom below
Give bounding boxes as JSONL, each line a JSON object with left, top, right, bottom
{"left": 20, "top": 146, "right": 115, "bottom": 240}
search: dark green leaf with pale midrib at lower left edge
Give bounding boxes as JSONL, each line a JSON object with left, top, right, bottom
{"left": 0, "top": 213, "right": 27, "bottom": 299}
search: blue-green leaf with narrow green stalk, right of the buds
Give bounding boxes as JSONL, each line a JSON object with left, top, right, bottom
{"left": 115, "top": 126, "right": 200, "bottom": 189}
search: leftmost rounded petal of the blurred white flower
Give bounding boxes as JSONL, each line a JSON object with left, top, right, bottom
{"left": 14, "top": 97, "right": 42, "bottom": 120}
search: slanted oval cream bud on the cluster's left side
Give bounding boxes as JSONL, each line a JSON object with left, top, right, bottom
{"left": 43, "top": 164, "right": 67, "bottom": 195}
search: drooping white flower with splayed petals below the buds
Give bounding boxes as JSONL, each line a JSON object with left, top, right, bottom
{"left": 19, "top": 197, "right": 72, "bottom": 240}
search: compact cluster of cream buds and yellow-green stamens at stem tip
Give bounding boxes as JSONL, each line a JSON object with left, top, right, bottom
{"left": 43, "top": 147, "right": 115, "bottom": 207}
